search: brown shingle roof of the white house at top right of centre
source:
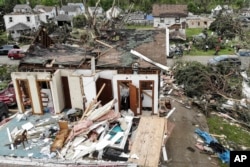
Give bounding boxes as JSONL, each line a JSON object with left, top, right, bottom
{"left": 153, "top": 4, "right": 188, "bottom": 17}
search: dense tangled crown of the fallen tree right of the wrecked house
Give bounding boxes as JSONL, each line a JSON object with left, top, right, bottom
{"left": 174, "top": 62, "right": 242, "bottom": 98}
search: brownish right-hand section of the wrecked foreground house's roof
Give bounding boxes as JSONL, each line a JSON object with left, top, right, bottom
{"left": 97, "top": 29, "right": 166, "bottom": 68}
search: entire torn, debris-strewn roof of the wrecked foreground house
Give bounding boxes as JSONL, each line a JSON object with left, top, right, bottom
{"left": 19, "top": 29, "right": 166, "bottom": 69}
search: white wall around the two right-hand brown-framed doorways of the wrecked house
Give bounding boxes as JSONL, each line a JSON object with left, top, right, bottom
{"left": 112, "top": 74, "right": 159, "bottom": 114}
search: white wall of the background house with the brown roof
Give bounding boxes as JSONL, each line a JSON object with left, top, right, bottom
{"left": 153, "top": 17, "right": 186, "bottom": 28}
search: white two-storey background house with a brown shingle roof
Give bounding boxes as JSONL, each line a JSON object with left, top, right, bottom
{"left": 152, "top": 4, "right": 188, "bottom": 28}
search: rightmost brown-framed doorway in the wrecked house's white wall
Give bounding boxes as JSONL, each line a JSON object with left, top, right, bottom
{"left": 139, "top": 80, "right": 154, "bottom": 115}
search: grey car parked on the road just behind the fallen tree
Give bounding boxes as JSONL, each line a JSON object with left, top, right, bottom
{"left": 208, "top": 55, "right": 241, "bottom": 66}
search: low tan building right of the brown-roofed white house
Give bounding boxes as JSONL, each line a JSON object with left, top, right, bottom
{"left": 186, "top": 15, "right": 215, "bottom": 28}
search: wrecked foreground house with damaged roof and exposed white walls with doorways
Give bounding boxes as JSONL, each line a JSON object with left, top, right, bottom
{"left": 11, "top": 30, "right": 167, "bottom": 115}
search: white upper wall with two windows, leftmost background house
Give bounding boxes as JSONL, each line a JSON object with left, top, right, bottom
{"left": 4, "top": 14, "right": 40, "bottom": 30}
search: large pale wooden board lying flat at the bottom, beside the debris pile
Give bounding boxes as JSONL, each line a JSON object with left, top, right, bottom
{"left": 129, "top": 116, "right": 166, "bottom": 167}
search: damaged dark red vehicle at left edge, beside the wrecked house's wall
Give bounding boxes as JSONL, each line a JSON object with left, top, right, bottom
{"left": 0, "top": 83, "right": 16, "bottom": 106}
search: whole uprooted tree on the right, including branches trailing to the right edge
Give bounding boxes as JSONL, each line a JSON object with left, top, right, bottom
{"left": 173, "top": 62, "right": 250, "bottom": 129}
